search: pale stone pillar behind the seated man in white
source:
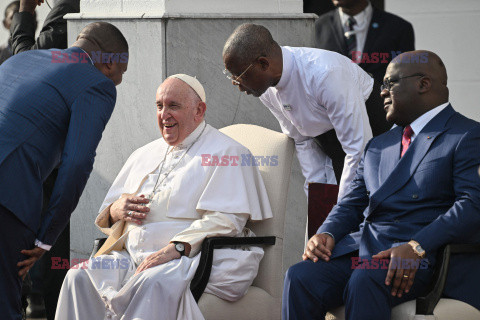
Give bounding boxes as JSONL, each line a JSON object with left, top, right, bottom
{"left": 66, "top": 0, "right": 316, "bottom": 276}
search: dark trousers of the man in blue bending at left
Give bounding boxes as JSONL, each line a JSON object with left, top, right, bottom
{"left": 0, "top": 205, "right": 35, "bottom": 320}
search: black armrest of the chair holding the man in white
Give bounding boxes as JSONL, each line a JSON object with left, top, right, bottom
{"left": 190, "top": 236, "right": 276, "bottom": 302}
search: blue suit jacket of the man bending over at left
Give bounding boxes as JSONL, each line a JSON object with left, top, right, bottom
{"left": 0, "top": 47, "right": 116, "bottom": 245}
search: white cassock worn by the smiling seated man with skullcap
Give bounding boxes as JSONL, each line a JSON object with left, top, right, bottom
{"left": 55, "top": 122, "right": 272, "bottom": 320}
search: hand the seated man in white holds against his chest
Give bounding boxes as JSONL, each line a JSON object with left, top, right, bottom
{"left": 110, "top": 195, "right": 150, "bottom": 225}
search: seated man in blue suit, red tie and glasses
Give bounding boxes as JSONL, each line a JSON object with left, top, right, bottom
{"left": 283, "top": 51, "right": 480, "bottom": 320}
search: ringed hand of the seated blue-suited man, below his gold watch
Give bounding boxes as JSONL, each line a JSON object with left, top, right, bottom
{"left": 372, "top": 243, "right": 421, "bottom": 298}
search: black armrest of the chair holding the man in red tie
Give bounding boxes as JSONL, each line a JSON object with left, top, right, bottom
{"left": 416, "top": 244, "right": 480, "bottom": 315}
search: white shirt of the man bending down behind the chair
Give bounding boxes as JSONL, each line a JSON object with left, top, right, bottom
{"left": 260, "top": 47, "right": 373, "bottom": 199}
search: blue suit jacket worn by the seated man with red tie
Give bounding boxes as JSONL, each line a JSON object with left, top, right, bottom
{"left": 318, "top": 106, "right": 480, "bottom": 309}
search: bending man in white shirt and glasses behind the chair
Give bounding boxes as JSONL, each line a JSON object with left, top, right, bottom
{"left": 223, "top": 24, "right": 373, "bottom": 199}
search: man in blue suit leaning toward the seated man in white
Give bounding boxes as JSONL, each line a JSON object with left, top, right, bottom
{"left": 0, "top": 22, "right": 128, "bottom": 319}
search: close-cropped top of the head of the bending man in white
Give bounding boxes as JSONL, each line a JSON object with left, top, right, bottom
{"left": 223, "top": 23, "right": 279, "bottom": 64}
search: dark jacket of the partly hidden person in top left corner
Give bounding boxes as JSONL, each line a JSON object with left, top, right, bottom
{"left": 10, "top": 0, "right": 80, "bottom": 54}
